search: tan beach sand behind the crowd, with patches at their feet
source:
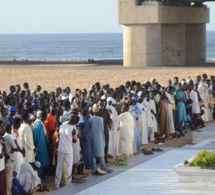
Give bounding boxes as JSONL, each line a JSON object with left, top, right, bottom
{"left": 0, "top": 64, "right": 215, "bottom": 195}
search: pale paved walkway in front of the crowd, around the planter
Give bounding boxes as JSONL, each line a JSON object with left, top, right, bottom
{"left": 49, "top": 125, "right": 215, "bottom": 195}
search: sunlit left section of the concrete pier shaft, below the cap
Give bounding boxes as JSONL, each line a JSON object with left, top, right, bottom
{"left": 123, "top": 24, "right": 161, "bottom": 66}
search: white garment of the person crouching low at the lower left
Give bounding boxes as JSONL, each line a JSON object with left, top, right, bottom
{"left": 17, "top": 162, "right": 41, "bottom": 192}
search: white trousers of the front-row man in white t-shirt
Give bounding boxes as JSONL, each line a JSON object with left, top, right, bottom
{"left": 55, "top": 152, "right": 73, "bottom": 188}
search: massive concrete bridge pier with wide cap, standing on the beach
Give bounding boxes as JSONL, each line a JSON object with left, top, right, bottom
{"left": 119, "top": 0, "right": 215, "bottom": 66}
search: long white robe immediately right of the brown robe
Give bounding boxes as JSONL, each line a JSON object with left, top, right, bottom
{"left": 165, "top": 92, "right": 175, "bottom": 134}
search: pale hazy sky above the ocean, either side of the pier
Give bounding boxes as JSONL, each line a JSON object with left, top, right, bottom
{"left": 0, "top": 0, "right": 215, "bottom": 33}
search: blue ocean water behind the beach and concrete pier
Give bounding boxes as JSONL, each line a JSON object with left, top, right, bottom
{"left": 0, "top": 31, "right": 215, "bottom": 61}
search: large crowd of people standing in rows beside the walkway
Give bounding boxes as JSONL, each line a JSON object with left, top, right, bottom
{"left": 0, "top": 74, "right": 215, "bottom": 195}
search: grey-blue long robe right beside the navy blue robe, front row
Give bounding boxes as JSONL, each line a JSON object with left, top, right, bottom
{"left": 89, "top": 116, "right": 105, "bottom": 157}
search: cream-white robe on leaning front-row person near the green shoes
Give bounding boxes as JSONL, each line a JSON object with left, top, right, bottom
{"left": 111, "top": 112, "right": 134, "bottom": 155}
